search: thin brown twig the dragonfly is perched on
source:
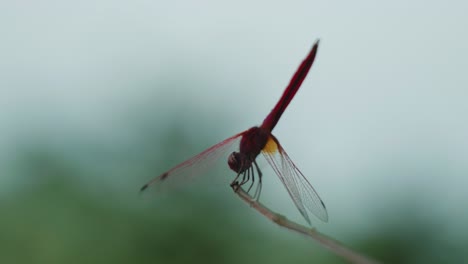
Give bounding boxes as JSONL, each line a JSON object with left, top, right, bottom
{"left": 232, "top": 185, "right": 380, "bottom": 264}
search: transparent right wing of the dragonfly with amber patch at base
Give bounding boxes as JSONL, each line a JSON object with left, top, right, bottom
{"left": 262, "top": 136, "right": 328, "bottom": 224}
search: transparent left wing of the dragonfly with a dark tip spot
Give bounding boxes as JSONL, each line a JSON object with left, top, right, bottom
{"left": 140, "top": 131, "right": 245, "bottom": 191}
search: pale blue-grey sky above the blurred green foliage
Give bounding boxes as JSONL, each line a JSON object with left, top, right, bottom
{"left": 0, "top": 1, "right": 468, "bottom": 242}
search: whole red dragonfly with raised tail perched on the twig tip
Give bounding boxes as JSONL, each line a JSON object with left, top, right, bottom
{"left": 141, "top": 41, "right": 328, "bottom": 224}
